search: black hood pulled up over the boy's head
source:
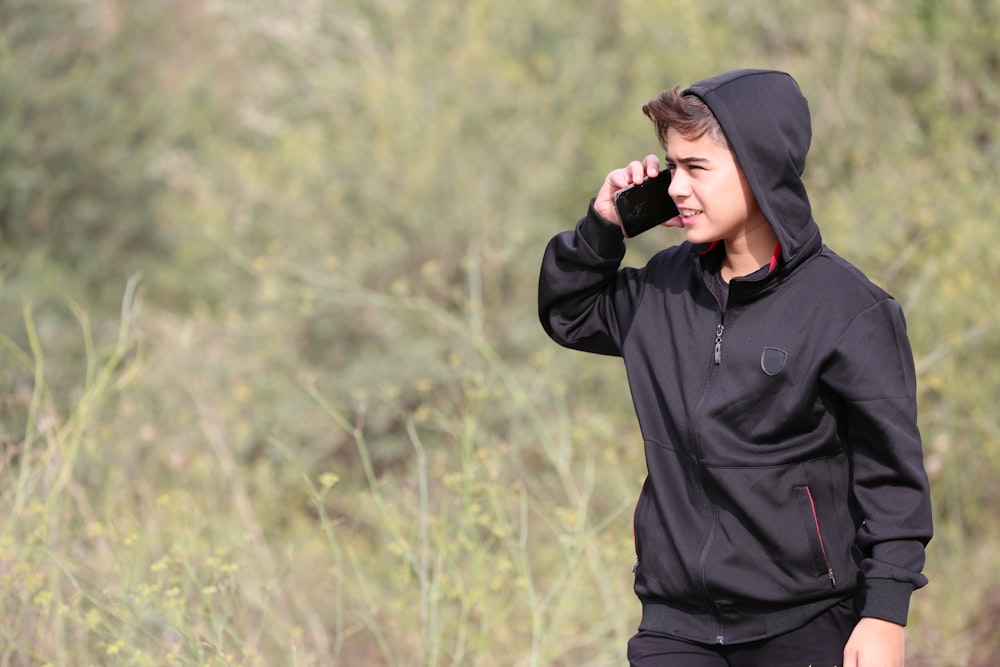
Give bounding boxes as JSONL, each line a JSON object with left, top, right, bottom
{"left": 682, "top": 69, "right": 822, "bottom": 266}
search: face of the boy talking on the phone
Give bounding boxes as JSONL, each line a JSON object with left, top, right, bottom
{"left": 667, "top": 128, "right": 768, "bottom": 247}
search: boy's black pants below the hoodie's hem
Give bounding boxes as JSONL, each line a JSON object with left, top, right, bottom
{"left": 628, "top": 600, "right": 858, "bottom": 667}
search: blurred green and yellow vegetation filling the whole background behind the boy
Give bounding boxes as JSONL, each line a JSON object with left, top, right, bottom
{"left": 0, "top": 0, "right": 1000, "bottom": 667}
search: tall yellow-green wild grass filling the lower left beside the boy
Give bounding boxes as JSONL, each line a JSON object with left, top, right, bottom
{"left": 0, "top": 274, "right": 638, "bottom": 666}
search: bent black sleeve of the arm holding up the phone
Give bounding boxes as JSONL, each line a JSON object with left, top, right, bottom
{"left": 538, "top": 201, "right": 627, "bottom": 356}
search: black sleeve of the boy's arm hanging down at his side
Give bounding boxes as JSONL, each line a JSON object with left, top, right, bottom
{"left": 825, "top": 297, "right": 933, "bottom": 625}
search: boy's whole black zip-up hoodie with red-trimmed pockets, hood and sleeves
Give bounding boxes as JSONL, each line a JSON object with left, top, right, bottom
{"left": 539, "top": 70, "right": 932, "bottom": 643}
